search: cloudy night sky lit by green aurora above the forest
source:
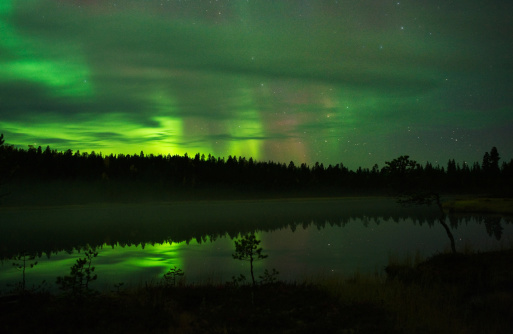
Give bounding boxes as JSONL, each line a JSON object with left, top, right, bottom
{"left": 0, "top": 0, "right": 513, "bottom": 169}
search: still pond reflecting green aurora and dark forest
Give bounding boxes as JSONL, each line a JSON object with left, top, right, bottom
{"left": 0, "top": 198, "right": 513, "bottom": 291}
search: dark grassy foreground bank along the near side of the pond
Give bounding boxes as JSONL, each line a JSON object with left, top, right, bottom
{"left": 0, "top": 250, "right": 513, "bottom": 334}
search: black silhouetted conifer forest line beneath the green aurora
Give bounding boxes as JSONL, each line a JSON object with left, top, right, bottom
{"left": 0, "top": 135, "right": 513, "bottom": 196}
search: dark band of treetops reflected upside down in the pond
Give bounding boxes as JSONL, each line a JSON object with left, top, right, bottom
{"left": 0, "top": 200, "right": 511, "bottom": 260}
